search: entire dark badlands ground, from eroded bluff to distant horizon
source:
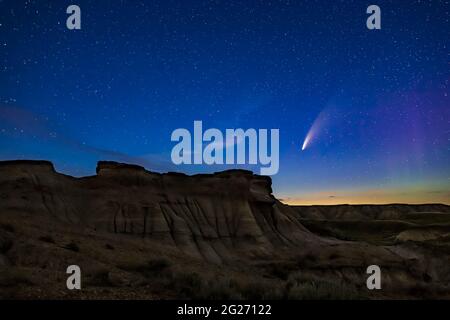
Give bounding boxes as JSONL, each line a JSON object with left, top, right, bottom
{"left": 0, "top": 161, "right": 450, "bottom": 299}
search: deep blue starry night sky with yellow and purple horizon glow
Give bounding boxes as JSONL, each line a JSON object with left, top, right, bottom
{"left": 0, "top": 0, "right": 450, "bottom": 204}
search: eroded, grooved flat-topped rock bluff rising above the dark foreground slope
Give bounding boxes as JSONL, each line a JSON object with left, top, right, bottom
{"left": 0, "top": 161, "right": 318, "bottom": 263}
